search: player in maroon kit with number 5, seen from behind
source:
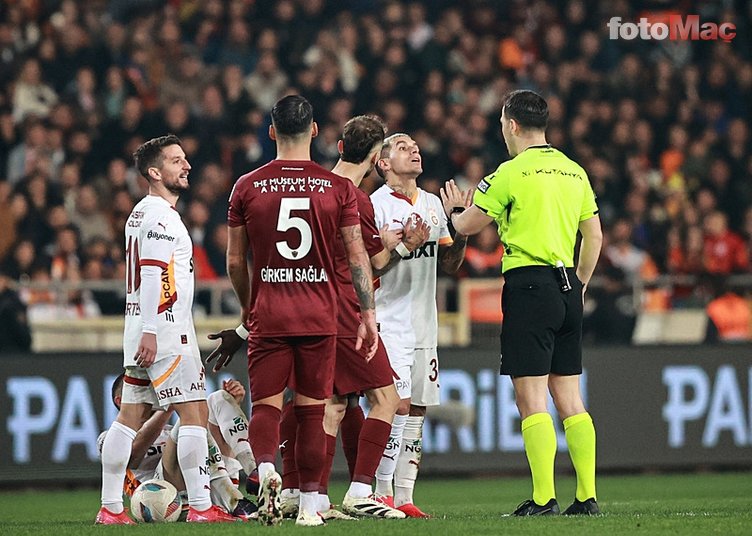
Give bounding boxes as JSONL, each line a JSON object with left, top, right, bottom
{"left": 222, "top": 95, "right": 378, "bottom": 525}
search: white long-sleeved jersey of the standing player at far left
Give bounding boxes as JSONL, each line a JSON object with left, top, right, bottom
{"left": 123, "top": 195, "right": 201, "bottom": 367}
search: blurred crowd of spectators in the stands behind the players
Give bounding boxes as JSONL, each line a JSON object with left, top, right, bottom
{"left": 0, "top": 0, "right": 752, "bottom": 352}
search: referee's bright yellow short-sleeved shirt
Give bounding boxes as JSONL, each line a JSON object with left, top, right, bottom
{"left": 473, "top": 146, "right": 598, "bottom": 273}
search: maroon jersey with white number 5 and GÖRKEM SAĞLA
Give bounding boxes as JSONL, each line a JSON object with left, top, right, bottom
{"left": 227, "top": 160, "right": 360, "bottom": 337}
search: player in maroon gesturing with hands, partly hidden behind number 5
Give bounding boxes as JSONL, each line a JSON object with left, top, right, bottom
{"left": 281, "top": 116, "right": 429, "bottom": 519}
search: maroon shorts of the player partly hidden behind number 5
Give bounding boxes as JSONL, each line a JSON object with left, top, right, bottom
{"left": 334, "top": 337, "right": 397, "bottom": 396}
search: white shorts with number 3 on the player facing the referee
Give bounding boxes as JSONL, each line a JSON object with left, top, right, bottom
{"left": 381, "top": 335, "right": 439, "bottom": 406}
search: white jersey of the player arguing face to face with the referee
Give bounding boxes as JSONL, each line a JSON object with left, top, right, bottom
{"left": 371, "top": 185, "right": 452, "bottom": 348}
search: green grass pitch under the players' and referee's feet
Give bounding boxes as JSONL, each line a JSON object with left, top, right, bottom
{"left": 0, "top": 473, "right": 752, "bottom": 536}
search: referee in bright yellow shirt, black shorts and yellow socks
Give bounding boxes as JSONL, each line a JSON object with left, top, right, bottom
{"left": 441, "top": 90, "right": 603, "bottom": 516}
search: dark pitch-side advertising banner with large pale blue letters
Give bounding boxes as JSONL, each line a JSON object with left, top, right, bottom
{"left": 0, "top": 346, "right": 752, "bottom": 483}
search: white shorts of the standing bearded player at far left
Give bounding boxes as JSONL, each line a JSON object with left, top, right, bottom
{"left": 122, "top": 355, "right": 206, "bottom": 408}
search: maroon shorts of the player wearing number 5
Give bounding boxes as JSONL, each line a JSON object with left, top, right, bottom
{"left": 248, "top": 335, "right": 337, "bottom": 401}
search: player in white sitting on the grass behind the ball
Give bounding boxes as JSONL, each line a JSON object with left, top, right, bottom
{"left": 97, "top": 374, "right": 256, "bottom": 518}
